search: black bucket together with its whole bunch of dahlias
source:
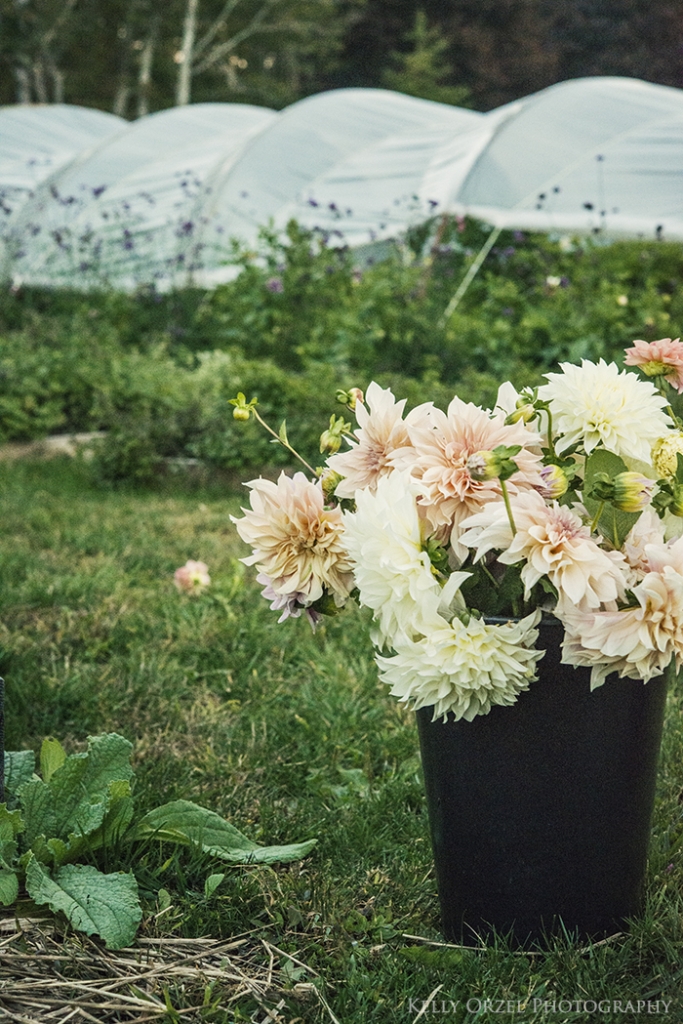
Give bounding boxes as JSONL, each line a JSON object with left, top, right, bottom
{"left": 232, "top": 339, "right": 683, "bottom": 942}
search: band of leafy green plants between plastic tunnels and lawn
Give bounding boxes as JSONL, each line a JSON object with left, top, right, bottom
{"left": 0, "top": 217, "right": 683, "bottom": 479}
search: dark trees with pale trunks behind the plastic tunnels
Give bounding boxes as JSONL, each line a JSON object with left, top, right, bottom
{"left": 0, "top": 0, "right": 683, "bottom": 118}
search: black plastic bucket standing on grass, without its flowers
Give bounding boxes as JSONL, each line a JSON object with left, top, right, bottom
{"left": 417, "top": 621, "right": 667, "bottom": 943}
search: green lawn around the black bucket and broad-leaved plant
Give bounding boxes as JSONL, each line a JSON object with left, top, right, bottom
{"left": 0, "top": 461, "right": 683, "bottom": 1024}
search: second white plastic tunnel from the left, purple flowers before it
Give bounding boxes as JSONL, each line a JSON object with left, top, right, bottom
{"left": 4, "top": 103, "right": 276, "bottom": 289}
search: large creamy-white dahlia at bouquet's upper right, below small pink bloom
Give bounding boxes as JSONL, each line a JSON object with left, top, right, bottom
{"left": 539, "top": 359, "right": 672, "bottom": 463}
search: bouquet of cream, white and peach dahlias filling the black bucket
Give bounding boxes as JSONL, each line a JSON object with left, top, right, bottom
{"left": 232, "top": 339, "right": 683, "bottom": 721}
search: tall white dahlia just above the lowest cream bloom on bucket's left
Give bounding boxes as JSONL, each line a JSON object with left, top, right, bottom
{"left": 344, "top": 473, "right": 441, "bottom": 646}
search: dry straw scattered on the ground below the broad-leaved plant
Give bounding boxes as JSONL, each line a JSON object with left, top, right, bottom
{"left": 0, "top": 921, "right": 338, "bottom": 1024}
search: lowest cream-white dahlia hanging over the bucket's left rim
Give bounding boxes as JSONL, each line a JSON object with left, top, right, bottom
{"left": 376, "top": 609, "right": 545, "bottom": 722}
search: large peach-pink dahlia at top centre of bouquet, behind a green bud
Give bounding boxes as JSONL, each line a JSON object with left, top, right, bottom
{"left": 393, "top": 397, "right": 543, "bottom": 560}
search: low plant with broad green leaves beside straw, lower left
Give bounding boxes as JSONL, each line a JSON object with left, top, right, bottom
{"left": 0, "top": 733, "right": 315, "bottom": 949}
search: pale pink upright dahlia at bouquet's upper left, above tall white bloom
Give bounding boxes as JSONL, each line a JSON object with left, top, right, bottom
{"left": 328, "top": 381, "right": 428, "bottom": 498}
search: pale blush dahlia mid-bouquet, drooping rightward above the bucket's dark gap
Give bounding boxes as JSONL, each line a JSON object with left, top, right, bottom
{"left": 461, "top": 490, "right": 627, "bottom": 608}
